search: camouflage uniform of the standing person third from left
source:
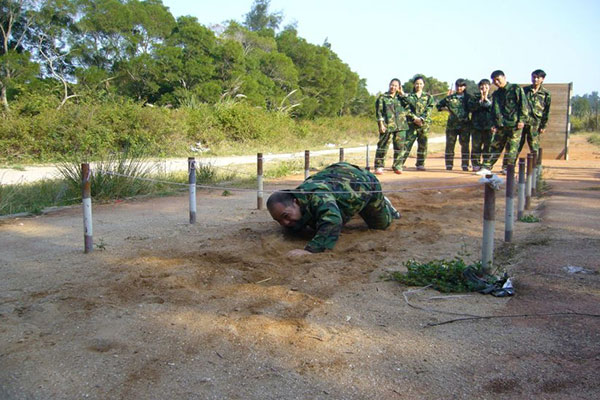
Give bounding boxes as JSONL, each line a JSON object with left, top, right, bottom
{"left": 437, "top": 93, "right": 471, "bottom": 169}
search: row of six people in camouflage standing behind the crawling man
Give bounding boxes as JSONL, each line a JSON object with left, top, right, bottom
{"left": 375, "top": 69, "right": 551, "bottom": 175}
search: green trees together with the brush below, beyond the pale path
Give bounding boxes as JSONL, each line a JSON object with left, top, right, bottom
{"left": 0, "top": 0, "right": 448, "bottom": 164}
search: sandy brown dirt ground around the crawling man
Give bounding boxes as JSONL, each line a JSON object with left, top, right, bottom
{"left": 0, "top": 136, "right": 600, "bottom": 399}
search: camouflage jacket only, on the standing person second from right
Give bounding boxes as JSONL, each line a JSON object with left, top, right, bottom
{"left": 492, "top": 82, "right": 528, "bottom": 128}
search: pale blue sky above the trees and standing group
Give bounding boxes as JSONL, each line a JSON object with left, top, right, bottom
{"left": 163, "top": 0, "right": 600, "bottom": 95}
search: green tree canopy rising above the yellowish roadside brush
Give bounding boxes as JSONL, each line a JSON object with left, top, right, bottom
{"left": 0, "top": 0, "right": 373, "bottom": 118}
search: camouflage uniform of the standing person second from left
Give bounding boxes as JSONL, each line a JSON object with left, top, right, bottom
{"left": 401, "top": 92, "right": 435, "bottom": 167}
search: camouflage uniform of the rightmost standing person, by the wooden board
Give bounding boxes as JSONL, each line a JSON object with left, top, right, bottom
{"left": 519, "top": 85, "right": 552, "bottom": 153}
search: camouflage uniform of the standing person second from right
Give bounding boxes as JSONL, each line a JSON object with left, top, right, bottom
{"left": 484, "top": 82, "right": 527, "bottom": 169}
